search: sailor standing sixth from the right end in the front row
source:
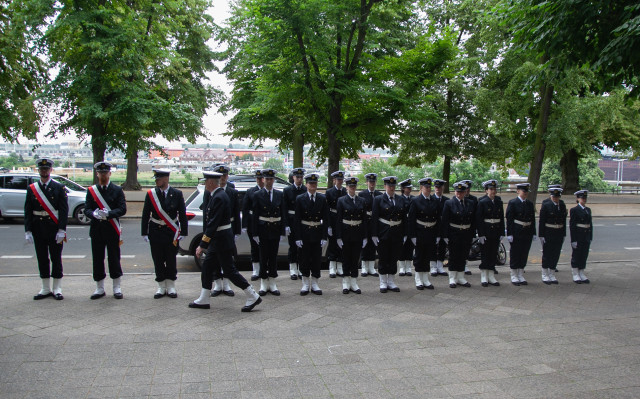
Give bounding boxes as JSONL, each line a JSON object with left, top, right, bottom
{"left": 407, "top": 177, "right": 440, "bottom": 290}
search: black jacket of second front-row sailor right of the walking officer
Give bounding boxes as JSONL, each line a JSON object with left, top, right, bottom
{"left": 293, "top": 192, "right": 329, "bottom": 242}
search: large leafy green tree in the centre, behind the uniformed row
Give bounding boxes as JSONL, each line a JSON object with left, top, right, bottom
{"left": 220, "top": 0, "right": 452, "bottom": 185}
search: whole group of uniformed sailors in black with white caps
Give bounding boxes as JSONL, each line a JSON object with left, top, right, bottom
{"left": 25, "top": 158, "right": 593, "bottom": 312}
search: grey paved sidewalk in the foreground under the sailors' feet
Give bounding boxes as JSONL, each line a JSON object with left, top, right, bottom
{"left": 0, "top": 262, "right": 640, "bottom": 399}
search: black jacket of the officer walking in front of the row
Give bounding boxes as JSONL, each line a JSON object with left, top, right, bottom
{"left": 200, "top": 187, "right": 235, "bottom": 251}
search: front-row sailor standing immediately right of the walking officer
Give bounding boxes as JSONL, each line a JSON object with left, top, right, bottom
{"left": 252, "top": 169, "right": 285, "bottom": 296}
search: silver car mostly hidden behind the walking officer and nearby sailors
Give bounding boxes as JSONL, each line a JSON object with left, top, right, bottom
{"left": 178, "top": 175, "right": 289, "bottom": 268}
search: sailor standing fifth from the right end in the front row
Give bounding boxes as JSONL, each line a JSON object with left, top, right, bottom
{"left": 442, "top": 182, "right": 476, "bottom": 288}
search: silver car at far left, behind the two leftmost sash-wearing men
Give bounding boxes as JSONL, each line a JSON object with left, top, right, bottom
{"left": 0, "top": 173, "right": 90, "bottom": 224}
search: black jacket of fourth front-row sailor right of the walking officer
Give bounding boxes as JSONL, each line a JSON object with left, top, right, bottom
{"left": 371, "top": 193, "right": 409, "bottom": 241}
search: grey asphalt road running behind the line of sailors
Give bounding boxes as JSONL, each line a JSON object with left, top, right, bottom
{"left": 0, "top": 217, "right": 640, "bottom": 275}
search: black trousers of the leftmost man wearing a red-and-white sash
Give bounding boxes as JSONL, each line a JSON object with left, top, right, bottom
{"left": 31, "top": 219, "right": 62, "bottom": 278}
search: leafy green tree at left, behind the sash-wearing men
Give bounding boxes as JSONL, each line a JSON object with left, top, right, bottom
{"left": 40, "top": 0, "right": 216, "bottom": 188}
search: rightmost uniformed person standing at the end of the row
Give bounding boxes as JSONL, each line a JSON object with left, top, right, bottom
{"left": 569, "top": 190, "right": 593, "bottom": 284}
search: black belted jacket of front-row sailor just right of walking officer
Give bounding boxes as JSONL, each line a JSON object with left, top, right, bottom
{"left": 251, "top": 188, "right": 285, "bottom": 239}
